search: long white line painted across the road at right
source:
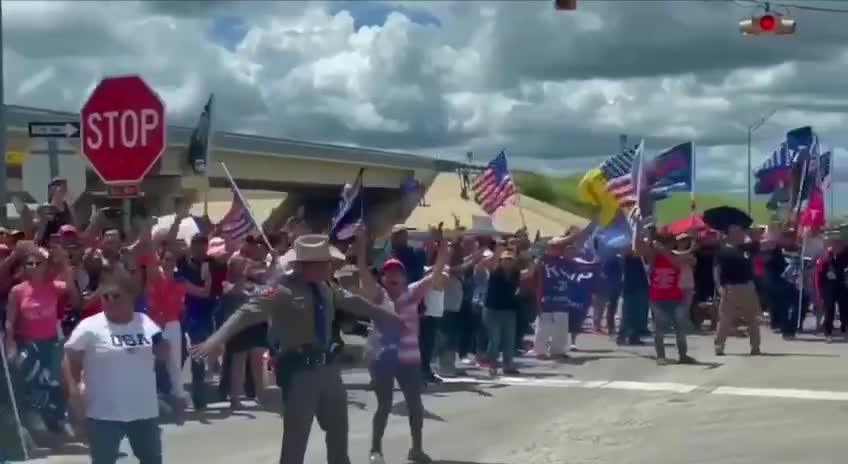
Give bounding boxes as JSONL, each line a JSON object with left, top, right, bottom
{"left": 438, "top": 377, "right": 848, "bottom": 401}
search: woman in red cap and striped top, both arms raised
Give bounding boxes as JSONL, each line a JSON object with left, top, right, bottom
{"left": 356, "top": 228, "right": 450, "bottom": 464}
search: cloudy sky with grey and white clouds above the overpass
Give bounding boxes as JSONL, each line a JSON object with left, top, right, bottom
{"left": 2, "top": 0, "right": 848, "bottom": 196}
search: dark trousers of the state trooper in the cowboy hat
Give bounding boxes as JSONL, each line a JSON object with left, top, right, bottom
{"left": 278, "top": 362, "right": 350, "bottom": 464}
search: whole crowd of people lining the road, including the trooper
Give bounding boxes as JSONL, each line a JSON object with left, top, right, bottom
{"left": 0, "top": 179, "right": 848, "bottom": 464}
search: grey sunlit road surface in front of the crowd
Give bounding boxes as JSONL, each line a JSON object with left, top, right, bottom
{"left": 23, "top": 334, "right": 848, "bottom": 464}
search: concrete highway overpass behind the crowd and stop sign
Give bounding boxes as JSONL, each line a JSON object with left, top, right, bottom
{"left": 1, "top": 105, "right": 460, "bottom": 234}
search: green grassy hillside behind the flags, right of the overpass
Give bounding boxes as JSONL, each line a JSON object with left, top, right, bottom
{"left": 513, "top": 171, "right": 770, "bottom": 224}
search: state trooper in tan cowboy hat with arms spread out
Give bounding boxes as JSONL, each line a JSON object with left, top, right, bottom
{"left": 192, "top": 235, "right": 400, "bottom": 464}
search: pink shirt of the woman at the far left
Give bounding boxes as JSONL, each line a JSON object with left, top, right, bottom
{"left": 9, "top": 281, "right": 67, "bottom": 340}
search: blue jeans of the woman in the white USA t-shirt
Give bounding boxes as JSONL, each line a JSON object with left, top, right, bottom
{"left": 86, "top": 418, "right": 162, "bottom": 464}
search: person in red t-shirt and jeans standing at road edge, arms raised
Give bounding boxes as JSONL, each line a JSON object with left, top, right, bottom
{"left": 633, "top": 229, "right": 696, "bottom": 366}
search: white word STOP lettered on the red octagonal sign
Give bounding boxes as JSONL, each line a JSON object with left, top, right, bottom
{"left": 85, "top": 108, "right": 160, "bottom": 150}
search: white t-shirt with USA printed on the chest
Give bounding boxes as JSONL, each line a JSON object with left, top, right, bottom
{"left": 65, "top": 313, "right": 162, "bottom": 422}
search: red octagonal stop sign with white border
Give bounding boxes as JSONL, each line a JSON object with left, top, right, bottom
{"left": 80, "top": 76, "right": 167, "bottom": 185}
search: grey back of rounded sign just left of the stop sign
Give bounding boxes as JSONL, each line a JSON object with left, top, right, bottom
{"left": 21, "top": 139, "right": 86, "bottom": 203}
